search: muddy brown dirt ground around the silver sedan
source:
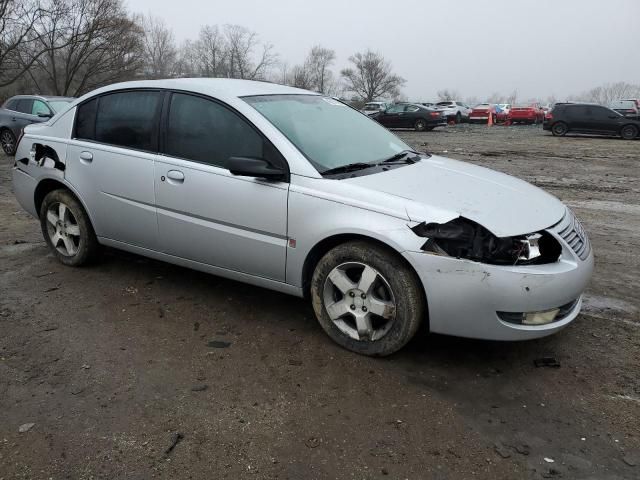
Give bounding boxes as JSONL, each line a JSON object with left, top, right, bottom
{"left": 0, "top": 125, "right": 640, "bottom": 480}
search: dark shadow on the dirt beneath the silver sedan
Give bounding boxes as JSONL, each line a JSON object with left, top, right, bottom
{"left": 96, "top": 249, "right": 562, "bottom": 372}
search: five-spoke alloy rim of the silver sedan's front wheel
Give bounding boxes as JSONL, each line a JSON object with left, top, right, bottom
{"left": 323, "top": 262, "right": 396, "bottom": 342}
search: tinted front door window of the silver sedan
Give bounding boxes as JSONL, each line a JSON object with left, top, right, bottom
{"left": 165, "top": 93, "right": 274, "bottom": 168}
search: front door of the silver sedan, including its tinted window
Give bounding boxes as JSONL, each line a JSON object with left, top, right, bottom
{"left": 154, "top": 93, "right": 289, "bottom": 281}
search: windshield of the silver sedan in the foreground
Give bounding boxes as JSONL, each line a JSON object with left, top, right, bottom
{"left": 243, "top": 95, "right": 411, "bottom": 173}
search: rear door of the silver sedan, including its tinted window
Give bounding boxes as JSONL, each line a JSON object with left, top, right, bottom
{"left": 65, "top": 90, "right": 164, "bottom": 250}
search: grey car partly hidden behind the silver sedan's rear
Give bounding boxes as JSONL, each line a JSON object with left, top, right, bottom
{"left": 0, "top": 95, "right": 75, "bottom": 155}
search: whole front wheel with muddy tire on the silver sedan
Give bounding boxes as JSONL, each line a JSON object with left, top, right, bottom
{"left": 311, "top": 241, "right": 425, "bottom": 356}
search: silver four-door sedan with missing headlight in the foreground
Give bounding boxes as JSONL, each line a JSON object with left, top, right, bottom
{"left": 13, "top": 79, "right": 593, "bottom": 355}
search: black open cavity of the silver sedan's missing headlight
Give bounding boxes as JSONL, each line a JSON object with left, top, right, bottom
{"left": 411, "top": 217, "right": 562, "bottom": 265}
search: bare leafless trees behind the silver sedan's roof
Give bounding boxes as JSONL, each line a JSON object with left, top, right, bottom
{"left": 0, "top": 0, "right": 405, "bottom": 101}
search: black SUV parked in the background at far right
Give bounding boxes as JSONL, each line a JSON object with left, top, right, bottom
{"left": 542, "top": 103, "right": 640, "bottom": 140}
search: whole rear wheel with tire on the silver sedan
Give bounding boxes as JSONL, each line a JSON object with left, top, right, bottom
{"left": 40, "top": 189, "right": 100, "bottom": 267}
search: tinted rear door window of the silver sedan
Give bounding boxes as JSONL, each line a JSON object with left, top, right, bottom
{"left": 95, "top": 91, "right": 162, "bottom": 151}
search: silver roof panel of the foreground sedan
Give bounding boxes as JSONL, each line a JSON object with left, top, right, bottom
{"left": 82, "top": 78, "right": 319, "bottom": 103}
